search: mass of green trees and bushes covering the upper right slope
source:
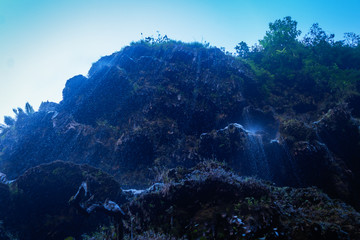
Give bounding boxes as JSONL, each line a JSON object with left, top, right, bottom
{"left": 239, "top": 17, "right": 360, "bottom": 105}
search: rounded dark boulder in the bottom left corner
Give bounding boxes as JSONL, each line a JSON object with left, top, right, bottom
{"left": 0, "top": 161, "right": 126, "bottom": 239}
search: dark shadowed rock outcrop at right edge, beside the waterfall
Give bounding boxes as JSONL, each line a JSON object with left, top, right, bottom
{"left": 280, "top": 106, "right": 360, "bottom": 208}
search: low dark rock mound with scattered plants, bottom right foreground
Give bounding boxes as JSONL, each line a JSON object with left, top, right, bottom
{"left": 128, "top": 163, "right": 360, "bottom": 239}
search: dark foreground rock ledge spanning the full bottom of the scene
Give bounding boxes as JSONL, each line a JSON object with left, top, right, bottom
{"left": 0, "top": 161, "right": 360, "bottom": 239}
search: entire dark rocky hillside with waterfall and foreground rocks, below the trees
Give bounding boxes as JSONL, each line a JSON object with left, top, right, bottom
{"left": 0, "top": 41, "right": 360, "bottom": 239}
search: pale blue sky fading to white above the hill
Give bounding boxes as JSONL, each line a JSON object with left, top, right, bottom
{"left": 0, "top": 0, "right": 360, "bottom": 123}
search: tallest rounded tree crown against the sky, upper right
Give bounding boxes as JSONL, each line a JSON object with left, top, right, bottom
{"left": 259, "top": 16, "right": 301, "bottom": 51}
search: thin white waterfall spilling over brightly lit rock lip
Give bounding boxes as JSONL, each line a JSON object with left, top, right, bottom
{"left": 240, "top": 107, "right": 301, "bottom": 186}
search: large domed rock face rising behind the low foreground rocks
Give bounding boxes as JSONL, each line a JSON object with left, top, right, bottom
{"left": 0, "top": 43, "right": 254, "bottom": 186}
